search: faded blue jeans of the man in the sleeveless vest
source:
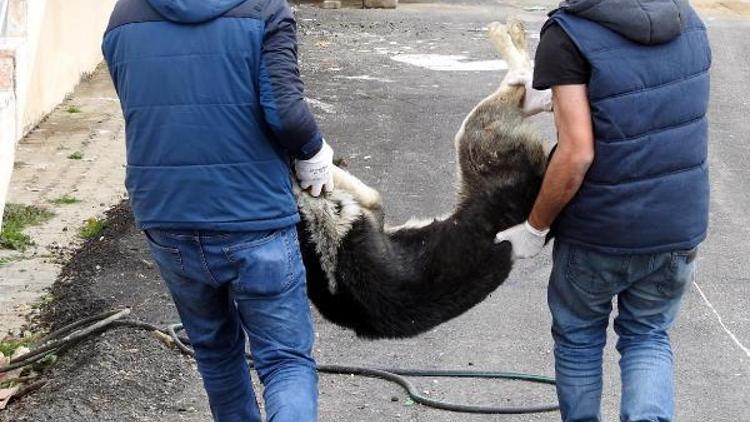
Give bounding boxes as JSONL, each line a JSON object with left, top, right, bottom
{"left": 548, "top": 241, "right": 696, "bottom": 422}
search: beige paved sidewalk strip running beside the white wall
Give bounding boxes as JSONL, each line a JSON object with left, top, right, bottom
{"left": 0, "top": 67, "right": 125, "bottom": 332}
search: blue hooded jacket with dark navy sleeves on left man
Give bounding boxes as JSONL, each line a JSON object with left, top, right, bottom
{"left": 102, "top": 0, "right": 322, "bottom": 231}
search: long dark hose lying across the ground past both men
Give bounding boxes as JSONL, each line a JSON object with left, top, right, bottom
{"left": 0, "top": 309, "right": 559, "bottom": 414}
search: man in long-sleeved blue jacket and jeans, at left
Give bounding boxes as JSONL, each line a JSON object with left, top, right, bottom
{"left": 103, "top": 0, "right": 333, "bottom": 422}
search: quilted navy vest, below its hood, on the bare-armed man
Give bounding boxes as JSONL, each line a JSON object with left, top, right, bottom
{"left": 551, "top": 8, "right": 711, "bottom": 254}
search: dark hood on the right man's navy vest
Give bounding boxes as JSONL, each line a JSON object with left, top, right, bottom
{"left": 560, "top": 0, "right": 689, "bottom": 45}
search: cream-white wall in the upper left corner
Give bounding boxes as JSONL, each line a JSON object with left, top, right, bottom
{"left": 0, "top": 0, "right": 117, "bottom": 227}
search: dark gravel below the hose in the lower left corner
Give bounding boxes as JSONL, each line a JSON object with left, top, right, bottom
{"left": 0, "top": 329, "right": 209, "bottom": 422}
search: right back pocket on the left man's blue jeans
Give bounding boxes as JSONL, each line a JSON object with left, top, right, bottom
{"left": 224, "top": 227, "right": 299, "bottom": 299}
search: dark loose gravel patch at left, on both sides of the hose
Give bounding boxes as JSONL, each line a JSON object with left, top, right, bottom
{"left": 0, "top": 203, "right": 210, "bottom": 422}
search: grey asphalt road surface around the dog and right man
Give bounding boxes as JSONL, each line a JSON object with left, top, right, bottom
{"left": 298, "top": 1, "right": 750, "bottom": 422}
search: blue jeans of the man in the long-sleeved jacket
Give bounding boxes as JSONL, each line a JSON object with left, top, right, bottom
{"left": 146, "top": 227, "right": 318, "bottom": 422}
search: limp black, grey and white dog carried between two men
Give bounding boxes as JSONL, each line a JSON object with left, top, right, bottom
{"left": 297, "top": 20, "right": 546, "bottom": 338}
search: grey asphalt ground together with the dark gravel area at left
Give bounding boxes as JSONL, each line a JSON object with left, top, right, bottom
{"left": 0, "top": 0, "right": 750, "bottom": 422}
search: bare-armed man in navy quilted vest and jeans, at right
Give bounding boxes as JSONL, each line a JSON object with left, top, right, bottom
{"left": 496, "top": 0, "right": 711, "bottom": 422}
